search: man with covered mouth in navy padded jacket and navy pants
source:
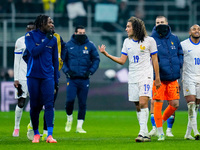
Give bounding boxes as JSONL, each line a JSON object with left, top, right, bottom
{"left": 61, "top": 26, "right": 100, "bottom": 133}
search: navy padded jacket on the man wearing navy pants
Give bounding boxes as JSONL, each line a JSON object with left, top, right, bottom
{"left": 61, "top": 35, "right": 100, "bottom": 78}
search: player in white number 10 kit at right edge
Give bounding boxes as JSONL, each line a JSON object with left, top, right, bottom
{"left": 181, "top": 24, "right": 200, "bottom": 140}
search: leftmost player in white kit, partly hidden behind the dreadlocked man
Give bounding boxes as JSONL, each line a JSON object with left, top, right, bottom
{"left": 13, "top": 22, "right": 35, "bottom": 137}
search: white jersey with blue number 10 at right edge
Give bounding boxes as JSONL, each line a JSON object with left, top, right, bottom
{"left": 181, "top": 38, "right": 200, "bottom": 83}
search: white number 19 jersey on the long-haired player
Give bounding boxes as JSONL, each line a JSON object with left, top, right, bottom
{"left": 122, "top": 36, "right": 157, "bottom": 83}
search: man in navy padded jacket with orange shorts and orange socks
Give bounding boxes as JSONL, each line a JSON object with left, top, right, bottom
{"left": 149, "top": 16, "right": 183, "bottom": 141}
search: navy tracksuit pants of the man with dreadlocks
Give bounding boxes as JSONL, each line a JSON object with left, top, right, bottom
{"left": 27, "top": 77, "right": 54, "bottom": 130}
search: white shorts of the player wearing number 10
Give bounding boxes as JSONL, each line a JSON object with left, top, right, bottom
{"left": 183, "top": 81, "right": 200, "bottom": 99}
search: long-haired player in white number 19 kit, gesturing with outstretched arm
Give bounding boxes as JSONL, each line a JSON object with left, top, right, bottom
{"left": 98, "top": 17, "right": 161, "bottom": 142}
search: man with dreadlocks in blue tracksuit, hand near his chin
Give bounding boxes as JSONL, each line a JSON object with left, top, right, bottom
{"left": 25, "top": 15, "right": 58, "bottom": 143}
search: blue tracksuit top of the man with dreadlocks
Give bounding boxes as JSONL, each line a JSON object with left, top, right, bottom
{"left": 25, "top": 30, "right": 58, "bottom": 83}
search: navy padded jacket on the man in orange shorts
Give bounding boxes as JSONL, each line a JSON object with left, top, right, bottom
{"left": 151, "top": 27, "right": 183, "bottom": 81}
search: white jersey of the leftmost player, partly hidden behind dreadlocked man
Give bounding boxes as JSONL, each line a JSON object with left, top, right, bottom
{"left": 14, "top": 36, "right": 27, "bottom": 81}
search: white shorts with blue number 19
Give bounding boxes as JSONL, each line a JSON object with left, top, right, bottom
{"left": 128, "top": 79, "right": 153, "bottom": 102}
